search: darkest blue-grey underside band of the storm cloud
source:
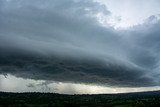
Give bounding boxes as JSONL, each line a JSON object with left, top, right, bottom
{"left": 1, "top": 55, "right": 155, "bottom": 86}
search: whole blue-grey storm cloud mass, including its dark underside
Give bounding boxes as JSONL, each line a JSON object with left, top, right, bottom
{"left": 0, "top": 0, "right": 160, "bottom": 87}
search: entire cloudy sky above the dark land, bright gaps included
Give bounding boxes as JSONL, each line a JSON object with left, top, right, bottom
{"left": 0, "top": 0, "right": 160, "bottom": 94}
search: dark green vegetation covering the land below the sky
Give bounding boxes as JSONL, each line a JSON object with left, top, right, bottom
{"left": 0, "top": 91, "right": 160, "bottom": 107}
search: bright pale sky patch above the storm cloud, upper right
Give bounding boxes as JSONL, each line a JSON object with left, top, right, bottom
{"left": 95, "top": 0, "right": 160, "bottom": 29}
